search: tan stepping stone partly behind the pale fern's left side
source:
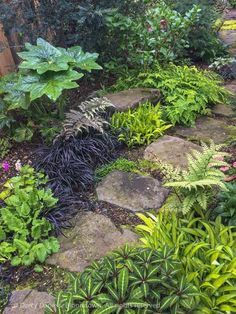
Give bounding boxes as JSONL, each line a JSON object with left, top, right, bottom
{"left": 144, "top": 135, "right": 201, "bottom": 168}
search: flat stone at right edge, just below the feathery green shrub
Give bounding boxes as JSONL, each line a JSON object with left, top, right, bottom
{"left": 173, "top": 117, "right": 236, "bottom": 144}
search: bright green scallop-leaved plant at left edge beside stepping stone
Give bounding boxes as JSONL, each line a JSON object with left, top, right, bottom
{"left": 0, "top": 166, "right": 59, "bottom": 266}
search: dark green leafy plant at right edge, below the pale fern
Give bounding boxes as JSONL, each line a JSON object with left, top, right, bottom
{"left": 213, "top": 182, "right": 236, "bottom": 226}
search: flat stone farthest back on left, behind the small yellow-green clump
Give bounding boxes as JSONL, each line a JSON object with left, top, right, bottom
{"left": 105, "top": 88, "right": 161, "bottom": 111}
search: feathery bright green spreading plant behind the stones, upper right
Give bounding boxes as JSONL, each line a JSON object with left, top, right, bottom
{"left": 114, "top": 64, "right": 229, "bottom": 126}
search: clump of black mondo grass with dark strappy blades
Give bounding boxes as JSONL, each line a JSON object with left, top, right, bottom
{"left": 34, "top": 133, "right": 119, "bottom": 196}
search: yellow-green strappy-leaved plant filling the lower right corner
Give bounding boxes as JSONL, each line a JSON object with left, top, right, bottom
{"left": 137, "top": 213, "right": 236, "bottom": 314}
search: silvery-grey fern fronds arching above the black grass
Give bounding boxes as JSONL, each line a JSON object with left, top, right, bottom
{"left": 57, "top": 97, "right": 113, "bottom": 140}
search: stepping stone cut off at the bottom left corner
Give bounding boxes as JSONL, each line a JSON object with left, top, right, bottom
{"left": 3, "top": 290, "right": 54, "bottom": 314}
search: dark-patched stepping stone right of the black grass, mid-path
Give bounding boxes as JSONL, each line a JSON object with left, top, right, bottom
{"left": 96, "top": 171, "right": 169, "bottom": 212}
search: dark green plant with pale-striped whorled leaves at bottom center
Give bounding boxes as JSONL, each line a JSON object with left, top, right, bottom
{"left": 46, "top": 246, "right": 198, "bottom": 314}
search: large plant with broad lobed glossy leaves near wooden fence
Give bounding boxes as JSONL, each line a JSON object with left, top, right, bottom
{"left": 0, "top": 38, "right": 101, "bottom": 141}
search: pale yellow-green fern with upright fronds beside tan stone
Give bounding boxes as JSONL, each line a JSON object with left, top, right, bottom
{"left": 165, "top": 142, "right": 228, "bottom": 214}
